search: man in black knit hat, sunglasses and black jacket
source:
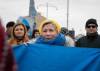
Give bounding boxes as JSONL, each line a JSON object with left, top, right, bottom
{"left": 76, "top": 18, "right": 100, "bottom": 48}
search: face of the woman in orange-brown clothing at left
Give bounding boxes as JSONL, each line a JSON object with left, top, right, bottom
{"left": 14, "top": 25, "right": 25, "bottom": 37}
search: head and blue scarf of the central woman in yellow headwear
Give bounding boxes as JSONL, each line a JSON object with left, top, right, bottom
{"left": 30, "top": 20, "right": 72, "bottom": 46}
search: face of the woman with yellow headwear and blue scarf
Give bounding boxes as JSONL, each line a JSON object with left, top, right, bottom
{"left": 42, "top": 24, "right": 57, "bottom": 39}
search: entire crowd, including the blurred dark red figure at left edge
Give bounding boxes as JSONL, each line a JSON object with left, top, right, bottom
{"left": 0, "top": 18, "right": 100, "bottom": 71}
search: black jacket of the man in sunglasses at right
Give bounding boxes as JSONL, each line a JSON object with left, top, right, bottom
{"left": 76, "top": 34, "right": 100, "bottom": 48}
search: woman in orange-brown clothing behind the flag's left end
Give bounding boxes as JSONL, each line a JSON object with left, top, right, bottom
{"left": 8, "top": 23, "right": 29, "bottom": 46}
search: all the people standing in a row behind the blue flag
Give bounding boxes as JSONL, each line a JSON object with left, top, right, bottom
{"left": 6, "top": 18, "right": 100, "bottom": 48}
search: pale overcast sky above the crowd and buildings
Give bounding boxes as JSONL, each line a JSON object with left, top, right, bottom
{"left": 0, "top": 0, "right": 100, "bottom": 34}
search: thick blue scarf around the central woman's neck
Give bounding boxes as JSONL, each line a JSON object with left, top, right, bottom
{"left": 35, "top": 34, "right": 66, "bottom": 46}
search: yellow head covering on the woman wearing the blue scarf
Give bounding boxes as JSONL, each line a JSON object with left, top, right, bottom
{"left": 39, "top": 19, "right": 61, "bottom": 34}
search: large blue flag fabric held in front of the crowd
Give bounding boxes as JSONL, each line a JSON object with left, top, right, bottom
{"left": 13, "top": 44, "right": 100, "bottom": 71}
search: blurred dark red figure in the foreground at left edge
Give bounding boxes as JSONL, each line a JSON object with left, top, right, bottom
{"left": 0, "top": 20, "right": 17, "bottom": 71}
